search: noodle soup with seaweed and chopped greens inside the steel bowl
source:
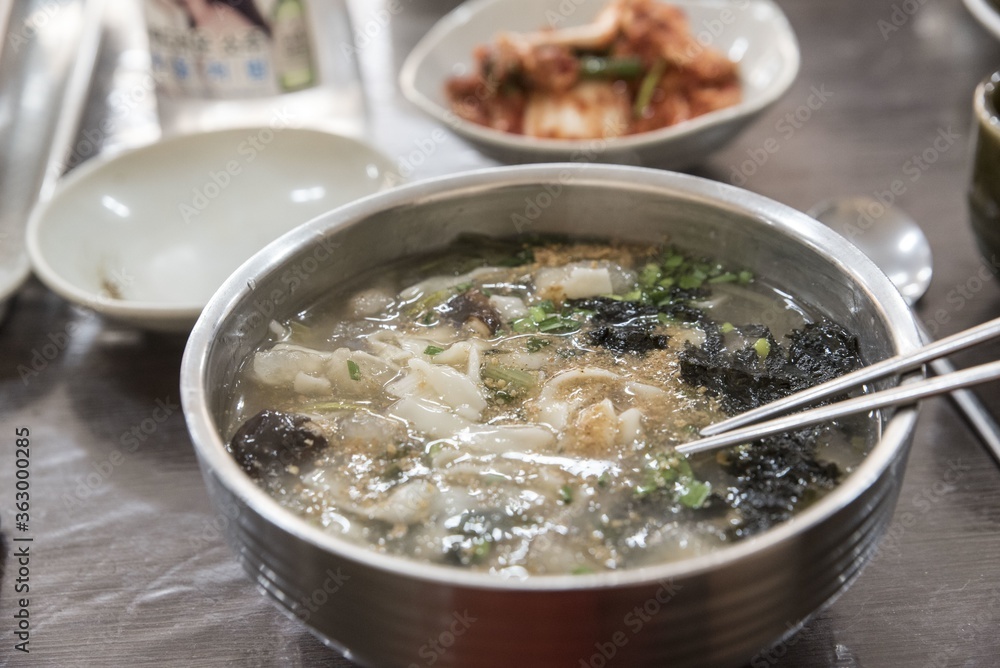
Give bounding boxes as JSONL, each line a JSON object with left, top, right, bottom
{"left": 227, "top": 237, "right": 877, "bottom": 577}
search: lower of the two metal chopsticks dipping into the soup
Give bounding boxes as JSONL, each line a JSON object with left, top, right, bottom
{"left": 677, "top": 361, "right": 1000, "bottom": 455}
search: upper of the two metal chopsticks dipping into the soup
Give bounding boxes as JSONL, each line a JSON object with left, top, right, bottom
{"left": 701, "top": 318, "right": 1000, "bottom": 436}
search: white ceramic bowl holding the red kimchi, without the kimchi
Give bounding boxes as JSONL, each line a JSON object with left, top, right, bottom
{"left": 399, "top": 0, "right": 799, "bottom": 169}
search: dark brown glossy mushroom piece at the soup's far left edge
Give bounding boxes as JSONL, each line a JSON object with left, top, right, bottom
{"left": 228, "top": 410, "right": 327, "bottom": 478}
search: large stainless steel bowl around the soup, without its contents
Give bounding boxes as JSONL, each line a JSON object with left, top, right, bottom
{"left": 181, "top": 164, "right": 918, "bottom": 668}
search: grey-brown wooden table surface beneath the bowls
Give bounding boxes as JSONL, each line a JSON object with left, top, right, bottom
{"left": 0, "top": 0, "right": 1000, "bottom": 668}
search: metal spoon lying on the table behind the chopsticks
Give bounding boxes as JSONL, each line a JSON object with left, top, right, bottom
{"left": 692, "top": 197, "right": 1000, "bottom": 463}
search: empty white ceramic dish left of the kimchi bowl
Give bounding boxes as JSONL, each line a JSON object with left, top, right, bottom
{"left": 27, "top": 127, "right": 392, "bottom": 331}
